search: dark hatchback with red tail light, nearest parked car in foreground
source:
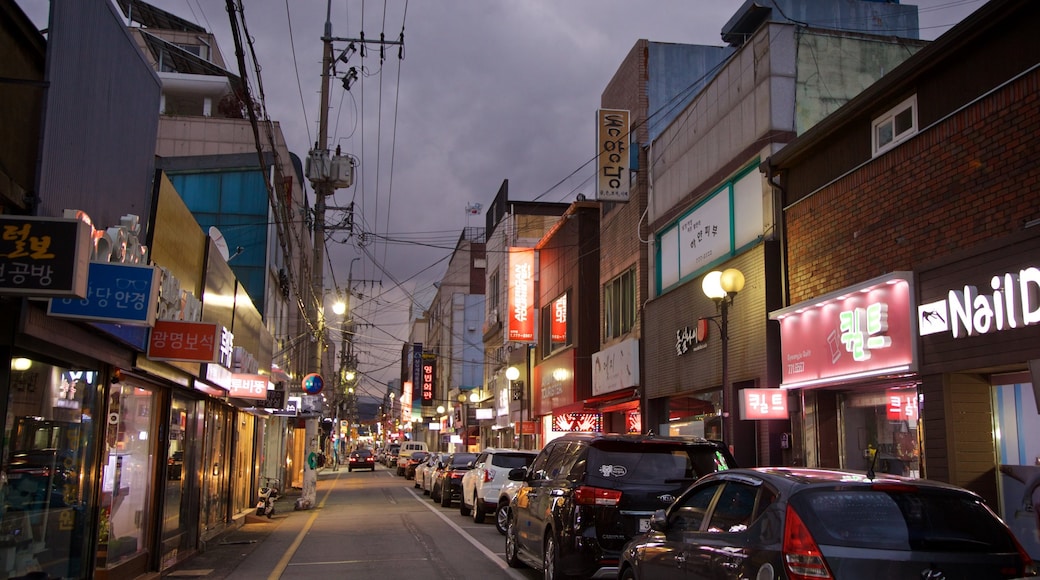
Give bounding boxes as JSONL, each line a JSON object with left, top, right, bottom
{"left": 619, "top": 468, "right": 1036, "bottom": 580}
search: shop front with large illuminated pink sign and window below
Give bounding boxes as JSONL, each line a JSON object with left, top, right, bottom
{"left": 770, "top": 272, "right": 924, "bottom": 477}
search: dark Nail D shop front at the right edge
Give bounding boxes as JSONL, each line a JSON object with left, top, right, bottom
{"left": 915, "top": 228, "right": 1040, "bottom": 558}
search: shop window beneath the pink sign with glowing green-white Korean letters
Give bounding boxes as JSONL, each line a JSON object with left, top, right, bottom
{"left": 838, "top": 387, "right": 920, "bottom": 477}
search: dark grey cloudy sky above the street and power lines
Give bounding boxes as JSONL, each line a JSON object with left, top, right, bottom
{"left": 16, "top": 0, "right": 985, "bottom": 394}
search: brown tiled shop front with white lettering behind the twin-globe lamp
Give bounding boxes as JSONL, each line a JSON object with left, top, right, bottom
{"left": 643, "top": 245, "right": 773, "bottom": 467}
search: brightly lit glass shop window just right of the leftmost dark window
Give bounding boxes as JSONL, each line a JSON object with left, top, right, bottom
{"left": 98, "top": 381, "right": 158, "bottom": 568}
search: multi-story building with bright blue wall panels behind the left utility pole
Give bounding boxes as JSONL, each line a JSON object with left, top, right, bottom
{"left": 120, "top": 0, "right": 312, "bottom": 494}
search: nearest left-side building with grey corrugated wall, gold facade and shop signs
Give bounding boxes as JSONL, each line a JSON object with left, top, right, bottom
{"left": 0, "top": 2, "right": 310, "bottom": 578}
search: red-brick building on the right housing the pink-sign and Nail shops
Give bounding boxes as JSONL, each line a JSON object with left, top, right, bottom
{"left": 765, "top": 0, "right": 1040, "bottom": 558}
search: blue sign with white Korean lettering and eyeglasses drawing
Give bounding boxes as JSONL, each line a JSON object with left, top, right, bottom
{"left": 47, "top": 262, "right": 159, "bottom": 326}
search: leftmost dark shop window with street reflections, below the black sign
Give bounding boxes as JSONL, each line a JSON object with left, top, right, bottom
{"left": 0, "top": 359, "right": 104, "bottom": 578}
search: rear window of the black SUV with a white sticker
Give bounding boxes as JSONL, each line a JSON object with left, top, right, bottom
{"left": 587, "top": 442, "right": 731, "bottom": 485}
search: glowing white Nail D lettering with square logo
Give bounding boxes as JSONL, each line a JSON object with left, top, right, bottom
{"left": 917, "top": 267, "right": 1040, "bottom": 338}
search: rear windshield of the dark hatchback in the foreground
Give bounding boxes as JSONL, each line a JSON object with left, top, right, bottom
{"left": 791, "top": 487, "right": 1016, "bottom": 552}
